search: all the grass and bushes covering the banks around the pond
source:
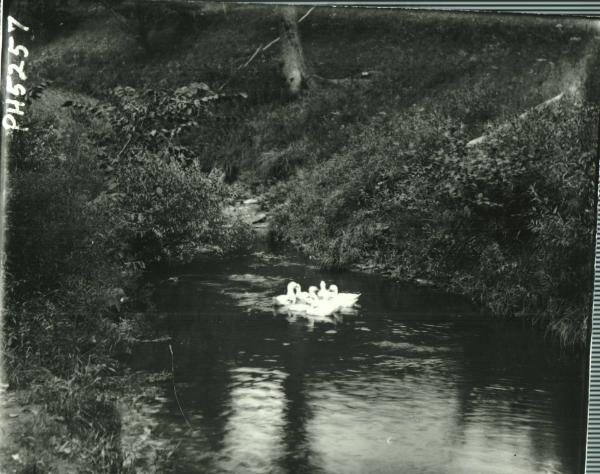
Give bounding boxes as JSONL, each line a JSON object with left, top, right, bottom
{"left": 5, "top": 6, "right": 597, "bottom": 472}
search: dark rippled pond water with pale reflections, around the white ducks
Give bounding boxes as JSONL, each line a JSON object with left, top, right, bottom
{"left": 133, "top": 250, "right": 585, "bottom": 474}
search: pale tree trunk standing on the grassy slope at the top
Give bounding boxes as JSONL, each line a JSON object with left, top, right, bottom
{"left": 280, "top": 5, "right": 312, "bottom": 95}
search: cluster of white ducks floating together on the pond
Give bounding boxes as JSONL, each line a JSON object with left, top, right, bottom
{"left": 273, "top": 281, "right": 360, "bottom": 317}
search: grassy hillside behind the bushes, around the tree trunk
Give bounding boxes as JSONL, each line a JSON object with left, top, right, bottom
{"left": 27, "top": 7, "right": 590, "bottom": 180}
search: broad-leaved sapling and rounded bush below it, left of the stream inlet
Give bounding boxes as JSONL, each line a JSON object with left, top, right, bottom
{"left": 66, "top": 83, "right": 250, "bottom": 264}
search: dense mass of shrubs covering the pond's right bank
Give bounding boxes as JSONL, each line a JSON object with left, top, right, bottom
{"left": 276, "top": 99, "right": 598, "bottom": 342}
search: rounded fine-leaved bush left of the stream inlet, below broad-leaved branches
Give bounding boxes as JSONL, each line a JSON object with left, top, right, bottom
{"left": 95, "top": 155, "right": 243, "bottom": 262}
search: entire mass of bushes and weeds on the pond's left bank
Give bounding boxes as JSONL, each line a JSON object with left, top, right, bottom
{"left": 5, "top": 49, "right": 252, "bottom": 472}
